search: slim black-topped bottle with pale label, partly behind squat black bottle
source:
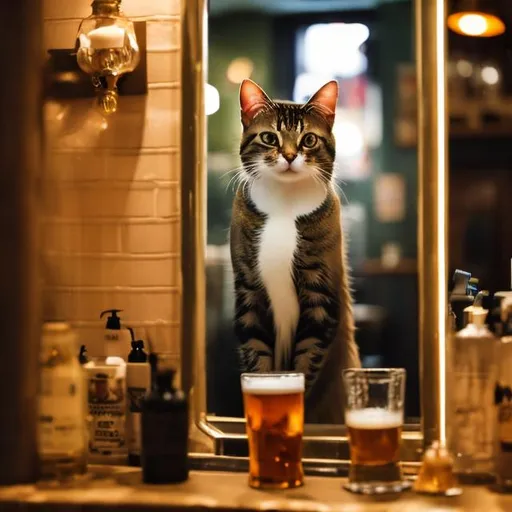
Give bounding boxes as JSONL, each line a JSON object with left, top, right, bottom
{"left": 126, "top": 327, "right": 151, "bottom": 466}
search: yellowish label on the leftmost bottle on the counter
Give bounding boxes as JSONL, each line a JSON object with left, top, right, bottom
{"left": 38, "top": 368, "right": 85, "bottom": 456}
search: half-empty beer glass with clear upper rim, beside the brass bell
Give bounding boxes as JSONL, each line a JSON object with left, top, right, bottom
{"left": 343, "top": 368, "right": 410, "bottom": 494}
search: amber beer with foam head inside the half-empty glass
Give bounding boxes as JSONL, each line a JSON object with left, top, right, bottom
{"left": 346, "top": 408, "right": 402, "bottom": 466}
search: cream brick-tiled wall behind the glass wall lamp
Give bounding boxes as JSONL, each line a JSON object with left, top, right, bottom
{"left": 43, "top": 0, "right": 181, "bottom": 364}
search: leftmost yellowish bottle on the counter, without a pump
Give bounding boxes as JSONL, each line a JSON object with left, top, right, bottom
{"left": 38, "top": 322, "right": 87, "bottom": 478}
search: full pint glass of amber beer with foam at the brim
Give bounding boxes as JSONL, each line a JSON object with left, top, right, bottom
{"left": 241, "top": 372, "right": 304, "bottom": 489}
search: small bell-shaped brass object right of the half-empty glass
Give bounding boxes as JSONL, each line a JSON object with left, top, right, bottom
{"left": 413, "top": 441, "right": 462, "bottom": 496}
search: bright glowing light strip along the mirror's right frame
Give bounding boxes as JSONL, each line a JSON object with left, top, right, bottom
{"left": 435, "top": 0, "right": 448, "bottom": 443}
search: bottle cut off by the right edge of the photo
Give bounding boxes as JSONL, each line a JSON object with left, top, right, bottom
{"left": 495, "top": 297, "right": 512, "bottom": 492}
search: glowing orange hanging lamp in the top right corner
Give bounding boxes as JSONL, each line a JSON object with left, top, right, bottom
{"left": 447, "top": 0, "right": 505, "bottom": 37}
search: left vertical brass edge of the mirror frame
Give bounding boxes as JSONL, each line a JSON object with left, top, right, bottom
{"left": 181, "top": 0, "right": 208, "bottom": 426}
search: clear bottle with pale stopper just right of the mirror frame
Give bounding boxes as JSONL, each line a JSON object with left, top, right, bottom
{"left": 448, "top": 308, "right": 498, "bottom": 483}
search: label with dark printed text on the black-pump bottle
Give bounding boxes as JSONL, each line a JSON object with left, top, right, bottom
{"left": 88, "top": 369, "right": 126, "bottom": 455}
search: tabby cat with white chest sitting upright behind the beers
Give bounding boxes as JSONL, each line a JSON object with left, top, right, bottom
{"left": 230, "top": 80, "right": 360, "bottom": 423}
